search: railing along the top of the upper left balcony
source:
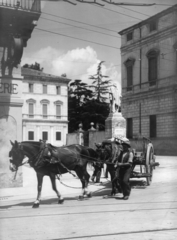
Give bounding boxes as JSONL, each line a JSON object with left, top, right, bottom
{"left": 0, "top": 0, "right": 41, "bottom": 12}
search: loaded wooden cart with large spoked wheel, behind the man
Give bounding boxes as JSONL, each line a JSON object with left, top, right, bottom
{"left": 102, "top": 137, "right": 159, "bottom": 185}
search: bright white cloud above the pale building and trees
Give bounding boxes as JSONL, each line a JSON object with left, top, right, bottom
{"left": 22, "top": 46, "right": 120, "bottom": 90}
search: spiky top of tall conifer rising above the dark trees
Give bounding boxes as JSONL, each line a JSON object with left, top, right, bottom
{"left": 89, "top": 61, "right": 111, "bottom": 102}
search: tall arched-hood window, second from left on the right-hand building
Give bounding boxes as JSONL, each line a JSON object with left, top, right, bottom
{"left": 147, "top": 49, "right": 159, "bottom": 86}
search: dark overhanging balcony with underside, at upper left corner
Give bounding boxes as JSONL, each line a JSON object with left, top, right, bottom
{"left": 0, "top": 0, "right": 41, "bottom": 47}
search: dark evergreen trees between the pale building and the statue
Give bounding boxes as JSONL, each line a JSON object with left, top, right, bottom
{"left": 68, "top": 61, "right": 111, "bottom": 133}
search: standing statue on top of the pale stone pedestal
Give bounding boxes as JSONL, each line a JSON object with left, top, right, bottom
{"left": 109, "top": 83, "right": 121, "bottom": 113}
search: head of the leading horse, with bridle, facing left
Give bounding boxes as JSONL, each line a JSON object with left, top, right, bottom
{"left": 9, "top": 141, "right": 25, "bottom": 172}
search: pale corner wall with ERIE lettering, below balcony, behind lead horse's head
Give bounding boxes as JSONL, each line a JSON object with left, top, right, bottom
{"left": 0, "top": 57, "right": 23, "bottom": 188}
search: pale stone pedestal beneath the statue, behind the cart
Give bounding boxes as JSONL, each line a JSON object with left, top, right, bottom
{"left": 105, "top": 112, "right": 126, "bottom": 139}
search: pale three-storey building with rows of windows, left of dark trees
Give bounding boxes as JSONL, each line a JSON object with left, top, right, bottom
{"left": 22, "top": 68, "right": 70, "bottom": 146}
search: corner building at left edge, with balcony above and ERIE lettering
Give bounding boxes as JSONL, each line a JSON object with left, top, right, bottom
{"left": 0, "top": 0, "right": 41, "bottom": 188}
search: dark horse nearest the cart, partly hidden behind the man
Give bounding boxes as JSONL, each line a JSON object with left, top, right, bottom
{"left": 96, "top": 143, "right": 122, "bottom": 196}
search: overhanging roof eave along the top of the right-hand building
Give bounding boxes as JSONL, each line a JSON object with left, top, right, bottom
{"left": 118, "top": 4, "right": 177, "bottom": 35}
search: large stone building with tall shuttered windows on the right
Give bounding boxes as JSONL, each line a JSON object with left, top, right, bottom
{"left": 119, "top": 5, "right": 177, "bottom": 155}
